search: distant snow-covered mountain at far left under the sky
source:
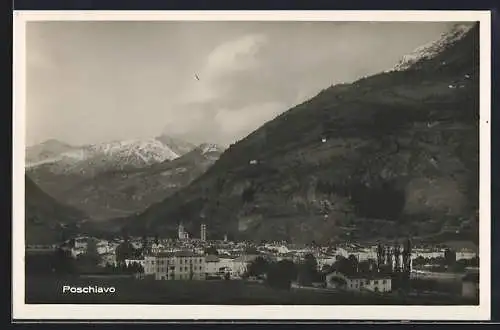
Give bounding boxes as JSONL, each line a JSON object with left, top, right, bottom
{"left": 26, "top": 135, "right": 194, "bottom": 209}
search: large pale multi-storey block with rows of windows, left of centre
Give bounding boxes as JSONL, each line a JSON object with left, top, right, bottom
{"left": 144, "top": 251, "right": 205, "bottom": 280}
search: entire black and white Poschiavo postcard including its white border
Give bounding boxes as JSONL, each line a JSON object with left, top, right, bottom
{"left": 13, "top": 12, "right": 491, "bottom": 320}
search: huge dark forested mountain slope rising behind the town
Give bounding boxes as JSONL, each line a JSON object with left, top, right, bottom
{"left": 124, "top": 26, "right": 479, "bottom": 241}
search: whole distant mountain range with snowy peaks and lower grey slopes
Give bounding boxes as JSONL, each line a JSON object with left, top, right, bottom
{"left": 26, "top": 134, "right": 223, "bottom": 220}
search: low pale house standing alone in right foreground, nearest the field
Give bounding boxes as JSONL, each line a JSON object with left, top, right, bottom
{"left": 325, "top": 272, "right": 392, "bottom": 292}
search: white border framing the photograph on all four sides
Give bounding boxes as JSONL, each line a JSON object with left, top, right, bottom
{"left": 12, "top": 11, "right": 491, "bottom": 321}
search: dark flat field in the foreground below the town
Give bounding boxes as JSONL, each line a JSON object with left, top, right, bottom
{"left": 26, "top": 276, "right": 478, "bottom": 305}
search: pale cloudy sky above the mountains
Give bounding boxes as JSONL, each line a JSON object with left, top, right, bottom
{"left": 26, "top": 21, "right": 453, "bottom": 146}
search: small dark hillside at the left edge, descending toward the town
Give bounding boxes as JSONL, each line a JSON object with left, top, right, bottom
{"left": 25, "top": 176, "right": 87, "bottom": 244}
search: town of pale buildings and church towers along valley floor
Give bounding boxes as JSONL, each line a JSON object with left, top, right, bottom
{"left": 26, "top": 224, "right": 479, "bottom": 299}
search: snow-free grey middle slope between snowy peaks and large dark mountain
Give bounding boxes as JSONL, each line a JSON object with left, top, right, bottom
{"left": 44, "top": 144, "right": 223, "bottom": 220}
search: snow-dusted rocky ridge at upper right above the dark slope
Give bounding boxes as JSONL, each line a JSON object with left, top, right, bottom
{"left": 390, "top": 23, "right": 474, "bottom": 71}
